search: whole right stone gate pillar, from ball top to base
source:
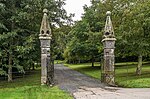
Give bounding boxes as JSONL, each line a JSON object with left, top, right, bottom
{"left": 101, "top": 11, "right": 116, "bottom": 86}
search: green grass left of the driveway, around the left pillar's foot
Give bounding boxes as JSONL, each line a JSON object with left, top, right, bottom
{"left": 0, "top": 70, "right": 73, "bottom": 99}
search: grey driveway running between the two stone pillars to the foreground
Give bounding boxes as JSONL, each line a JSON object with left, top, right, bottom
{"left": 55, "top": 64, "right": 150, "bottom": 99}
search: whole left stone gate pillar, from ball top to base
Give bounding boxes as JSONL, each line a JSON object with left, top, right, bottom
{"left": 39, "top": 9, "right": 54, "bottom": 85}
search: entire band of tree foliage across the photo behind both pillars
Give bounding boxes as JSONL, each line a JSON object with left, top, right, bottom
{"left": 0, "top": 0, "right": 150, "bottom": 81}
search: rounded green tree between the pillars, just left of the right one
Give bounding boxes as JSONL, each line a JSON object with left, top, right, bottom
{"left": 64, "top": 1, "right": 104, "bottom": 66}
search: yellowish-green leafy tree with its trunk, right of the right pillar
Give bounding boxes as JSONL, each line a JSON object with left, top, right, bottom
{"left": 120, "top": 0, "right": 150, "bottom": 75}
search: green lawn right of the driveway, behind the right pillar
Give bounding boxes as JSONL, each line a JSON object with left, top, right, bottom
{"left": 65, "top": 62, "right": 150, "bottom": 88}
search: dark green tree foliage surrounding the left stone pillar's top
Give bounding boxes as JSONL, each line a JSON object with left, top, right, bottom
{"left": 0, "top": 0, "right": 72, "bottom": 81}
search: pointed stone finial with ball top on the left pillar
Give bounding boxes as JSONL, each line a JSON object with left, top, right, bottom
{"left": 39, "top": 9, "right": 52, "bottom": 38}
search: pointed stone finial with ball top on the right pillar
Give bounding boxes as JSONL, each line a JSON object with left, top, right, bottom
{"left": 104, "top": 11, "right": 114, "bottom": 38}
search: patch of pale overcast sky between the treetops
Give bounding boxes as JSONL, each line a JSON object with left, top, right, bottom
{"left": 64, "top": 0, "right": 90, "bottom": 20}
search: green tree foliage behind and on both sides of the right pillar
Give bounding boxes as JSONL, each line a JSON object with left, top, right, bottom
{"left": 64, "top": 0, "right": 150, "bottom": 74}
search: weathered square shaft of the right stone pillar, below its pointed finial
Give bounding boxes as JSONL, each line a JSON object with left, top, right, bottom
{"left": 102, "top": 38, "right": 115, "bottom": 85}
